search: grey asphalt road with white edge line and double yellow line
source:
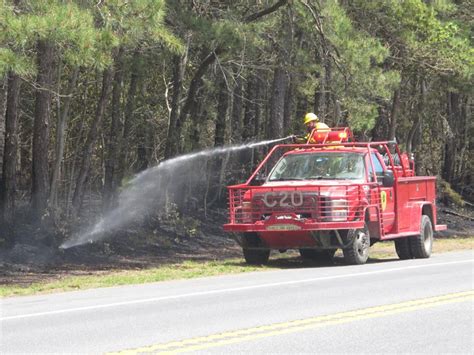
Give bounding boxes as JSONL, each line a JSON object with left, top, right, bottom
{"left": 0, "top": 251, "right": 474, "bottom": 354}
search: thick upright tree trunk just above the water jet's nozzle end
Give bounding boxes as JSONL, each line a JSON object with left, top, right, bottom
{"left": 268, "top": 66, "right": 287, "bottom": 138}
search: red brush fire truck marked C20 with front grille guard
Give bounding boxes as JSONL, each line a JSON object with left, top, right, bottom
{"left": 224, "top": 128, "right": 446, "bottom": 264}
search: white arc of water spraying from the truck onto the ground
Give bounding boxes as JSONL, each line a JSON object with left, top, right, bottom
{"left": 59, "top": 136, "right": 293, "bottom": 249}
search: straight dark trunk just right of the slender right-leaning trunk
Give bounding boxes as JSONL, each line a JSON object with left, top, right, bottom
{"left": 103, "top": 48, "right": 124, "bottom": 209}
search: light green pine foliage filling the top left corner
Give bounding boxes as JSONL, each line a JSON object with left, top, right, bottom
{"left": 0, "top": 0, "right": 182, "bottom": 75}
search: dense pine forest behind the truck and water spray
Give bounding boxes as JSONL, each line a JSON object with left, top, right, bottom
{"left": 0, "top": 0, "right": 474, "bottom": 245}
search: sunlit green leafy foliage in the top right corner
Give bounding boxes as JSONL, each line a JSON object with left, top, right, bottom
{"left": 350, "top": 0, "right": 474, "bottom": 80}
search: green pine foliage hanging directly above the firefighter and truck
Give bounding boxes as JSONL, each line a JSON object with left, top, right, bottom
{"left": 299, "top": 1, "right": 400, "bottom": 131}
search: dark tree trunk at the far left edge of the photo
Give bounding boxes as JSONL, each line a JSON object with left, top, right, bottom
{"left": 0, "top": 73, "right": 20, "bottom": 224}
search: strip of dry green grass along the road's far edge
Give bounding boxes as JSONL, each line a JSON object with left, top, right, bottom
{"left": 0, "top": 237, "right": 474, "bottom": 297}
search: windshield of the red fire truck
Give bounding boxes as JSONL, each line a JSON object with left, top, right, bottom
{"left": 267, "top": 152, "right": 365, "bottom": 181}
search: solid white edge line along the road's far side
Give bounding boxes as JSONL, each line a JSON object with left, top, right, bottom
{"left": 0, "top": 259, "right": 474, "bottom": 321}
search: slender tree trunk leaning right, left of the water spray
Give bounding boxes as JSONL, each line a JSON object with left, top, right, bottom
{"left": 72, "top": 68, "right": 112, "bottom": 215}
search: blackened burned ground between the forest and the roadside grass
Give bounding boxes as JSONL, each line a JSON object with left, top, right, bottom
{"left": 0, "top": 206, "right": 474, "bottom": 286}
